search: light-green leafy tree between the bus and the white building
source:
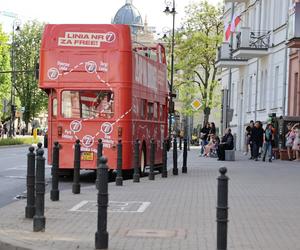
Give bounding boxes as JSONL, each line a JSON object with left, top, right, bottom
{"left": 175, "top": 0, "right": 223, "bottom": 123}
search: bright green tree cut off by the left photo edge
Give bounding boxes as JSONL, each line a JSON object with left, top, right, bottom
{"left": 0, "top": 25, "right": 11, "bottom": 121}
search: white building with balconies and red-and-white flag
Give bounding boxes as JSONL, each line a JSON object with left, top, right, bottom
{"left": 217, "top": 0, "right": 292, "bottom": 150}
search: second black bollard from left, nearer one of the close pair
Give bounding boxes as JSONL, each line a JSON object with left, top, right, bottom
{"left": 33, "top": 147, "right": 46, "bottom": 232}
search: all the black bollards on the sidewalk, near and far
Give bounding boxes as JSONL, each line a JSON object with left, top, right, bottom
{"left": 25, "top": 139, "right": 229, "bottom": 250}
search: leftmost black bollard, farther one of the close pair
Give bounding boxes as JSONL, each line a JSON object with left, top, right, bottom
{"left": 25, "top": 147, "right": 35, "bottom": 218}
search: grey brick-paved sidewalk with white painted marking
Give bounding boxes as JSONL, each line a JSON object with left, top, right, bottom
{"left": 0, "top": 149, "right": 300, "bottom": 250}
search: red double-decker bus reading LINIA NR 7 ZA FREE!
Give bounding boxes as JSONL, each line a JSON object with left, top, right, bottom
{"left": 39, "top": 24, "right": 168, "bottom": 175}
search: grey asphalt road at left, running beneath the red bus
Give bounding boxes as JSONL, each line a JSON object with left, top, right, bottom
{"left": 0, "top": 146, "right": 95, "bottom": 207}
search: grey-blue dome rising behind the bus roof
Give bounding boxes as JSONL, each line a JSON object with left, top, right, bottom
{"left": 112, "top": 0, "right": 144, "bottom": 33}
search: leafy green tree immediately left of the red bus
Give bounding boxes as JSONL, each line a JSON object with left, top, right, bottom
{"left": 13, "top": 21, "right": 48, "bottom": 128}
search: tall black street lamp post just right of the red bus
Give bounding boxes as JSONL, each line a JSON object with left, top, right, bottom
{"left": 164, "top": 0, "right": 176, "bottom": 145}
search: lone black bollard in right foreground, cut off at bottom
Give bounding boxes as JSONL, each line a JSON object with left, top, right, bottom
{"left": 217, "top": 167, "right": 229, "bottom": 250}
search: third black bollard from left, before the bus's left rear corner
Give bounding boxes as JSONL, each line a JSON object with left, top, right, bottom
{"left": 50, "top": 141, "right": 59, "bottom": 201}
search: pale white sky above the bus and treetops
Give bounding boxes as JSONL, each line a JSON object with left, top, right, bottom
{"left": 0, "top": 0, "right": 223, "bottom": 33}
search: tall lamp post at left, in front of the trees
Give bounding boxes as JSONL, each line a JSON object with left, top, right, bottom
{"left": 9, "top": 19, "right": 20, "bottom": 137}
